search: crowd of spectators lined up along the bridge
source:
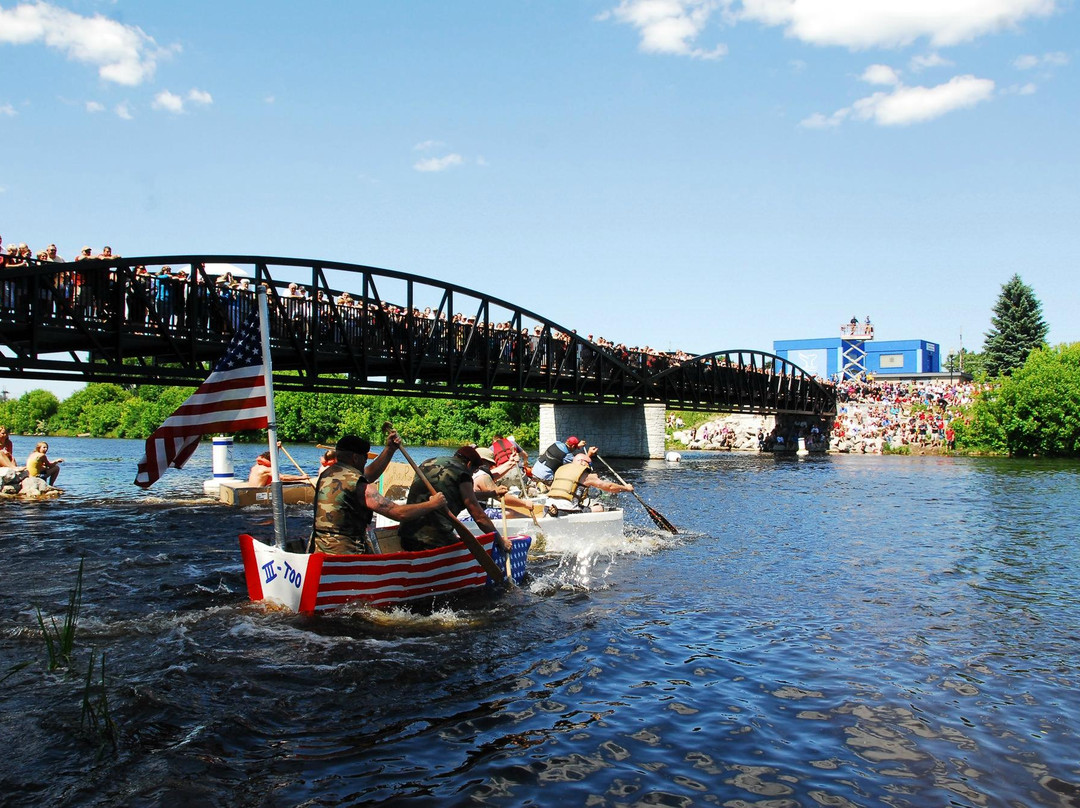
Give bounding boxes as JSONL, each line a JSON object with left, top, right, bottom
{"left": 0, "top": 239, "right": 794, "bottom": 386}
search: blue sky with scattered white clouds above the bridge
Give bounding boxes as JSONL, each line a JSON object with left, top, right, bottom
{"left": 0, "top": 0, "right": 1080, "bottom": 394}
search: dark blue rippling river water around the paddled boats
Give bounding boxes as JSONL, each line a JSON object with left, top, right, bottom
{"left": 0, "top": 437, "right": 1080, "bottom": 808}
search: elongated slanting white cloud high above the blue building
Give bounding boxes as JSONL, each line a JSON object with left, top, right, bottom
{"left": 799, "top": 76, "right": 995, "bottom": 129}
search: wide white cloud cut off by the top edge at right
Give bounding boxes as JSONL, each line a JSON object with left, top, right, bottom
{"left": 724, "top": 0, "right": 1056, "bottom": 49}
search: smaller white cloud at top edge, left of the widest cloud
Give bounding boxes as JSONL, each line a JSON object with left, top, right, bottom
{"left": 598, "top": 0, "right": 730, "bottom": 59}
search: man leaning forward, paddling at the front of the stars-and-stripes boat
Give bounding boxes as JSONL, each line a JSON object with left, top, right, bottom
{"left": 397, "top": 446, "right": 510, "bottom": 550}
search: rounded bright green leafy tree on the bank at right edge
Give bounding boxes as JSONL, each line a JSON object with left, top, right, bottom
{"left": 958, "top": 342, "right": 1080, "bottom": 457}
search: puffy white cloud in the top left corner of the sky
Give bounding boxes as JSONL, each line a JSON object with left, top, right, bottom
{"left": 0, "top": 2, "right": 178, "bottom": 86}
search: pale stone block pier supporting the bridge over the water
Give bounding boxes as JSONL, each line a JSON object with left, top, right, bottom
{"left": 540, "top": 404, "right": 666, "bottom": 459}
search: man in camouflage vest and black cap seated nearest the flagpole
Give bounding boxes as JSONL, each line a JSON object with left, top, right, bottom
{"left": 311, "top": 431, "right": 446, "bottom": 555}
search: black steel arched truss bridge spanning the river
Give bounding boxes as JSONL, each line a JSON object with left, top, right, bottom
{"left": 0, "top": 255, "right": 835, "bottom": 413}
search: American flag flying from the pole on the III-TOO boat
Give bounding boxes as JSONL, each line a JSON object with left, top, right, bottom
{"left": 135, "top": 311, "right": 270, "bottom": 488}
